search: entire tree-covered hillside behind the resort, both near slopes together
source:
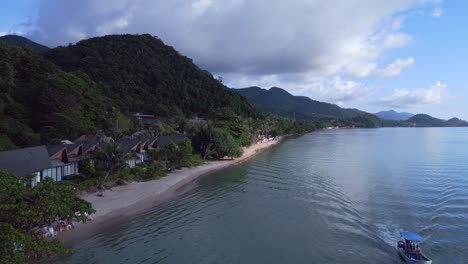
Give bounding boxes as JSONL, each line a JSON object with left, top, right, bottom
{"left": 0, "top": 35, "right": 257, "bottom": 150}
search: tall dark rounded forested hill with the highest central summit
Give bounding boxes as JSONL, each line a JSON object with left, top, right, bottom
{"left": 47, "top": 34, "right": 256, "bottom": 116}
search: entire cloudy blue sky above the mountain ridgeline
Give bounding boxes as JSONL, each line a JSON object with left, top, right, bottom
{"left": 0, "top": 0, "right": 468, "bottom": 120}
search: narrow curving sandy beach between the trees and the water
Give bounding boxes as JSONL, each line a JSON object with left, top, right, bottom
{"left": 57, "top": 137, "right": 283, "bottom": 246}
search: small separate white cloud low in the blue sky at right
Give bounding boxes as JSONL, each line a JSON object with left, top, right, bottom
{"left": 379, "top": 82, "right": 447, "bottom": 108}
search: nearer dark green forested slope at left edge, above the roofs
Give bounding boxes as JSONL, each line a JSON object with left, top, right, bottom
{"left": 0, "top": 43, "right": 109, "bottom": 150}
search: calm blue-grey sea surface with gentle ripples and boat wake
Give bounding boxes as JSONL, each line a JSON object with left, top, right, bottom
{"left": 59, "top": 128, "right": 468, "bottom": 264}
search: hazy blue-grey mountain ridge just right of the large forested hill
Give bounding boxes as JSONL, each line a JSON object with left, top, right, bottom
{"left": 238, "top": 87, "right": 366, "bottom": 119}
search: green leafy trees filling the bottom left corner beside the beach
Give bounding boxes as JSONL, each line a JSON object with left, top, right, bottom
{"left": 0, "top": 170, "right": 95, "bottom": 264}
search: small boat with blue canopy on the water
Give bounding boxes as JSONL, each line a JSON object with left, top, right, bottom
{"left": 397, "top": 232, "right": 432, "bottom": 264}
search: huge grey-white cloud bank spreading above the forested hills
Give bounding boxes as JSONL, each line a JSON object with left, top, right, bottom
{"left": 21, "top": 0, "right": 434, "bottom": 102}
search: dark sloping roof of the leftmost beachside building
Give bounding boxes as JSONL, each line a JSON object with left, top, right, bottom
{"left": 0, "top": 146, "right": 52, "bottom": 176}
